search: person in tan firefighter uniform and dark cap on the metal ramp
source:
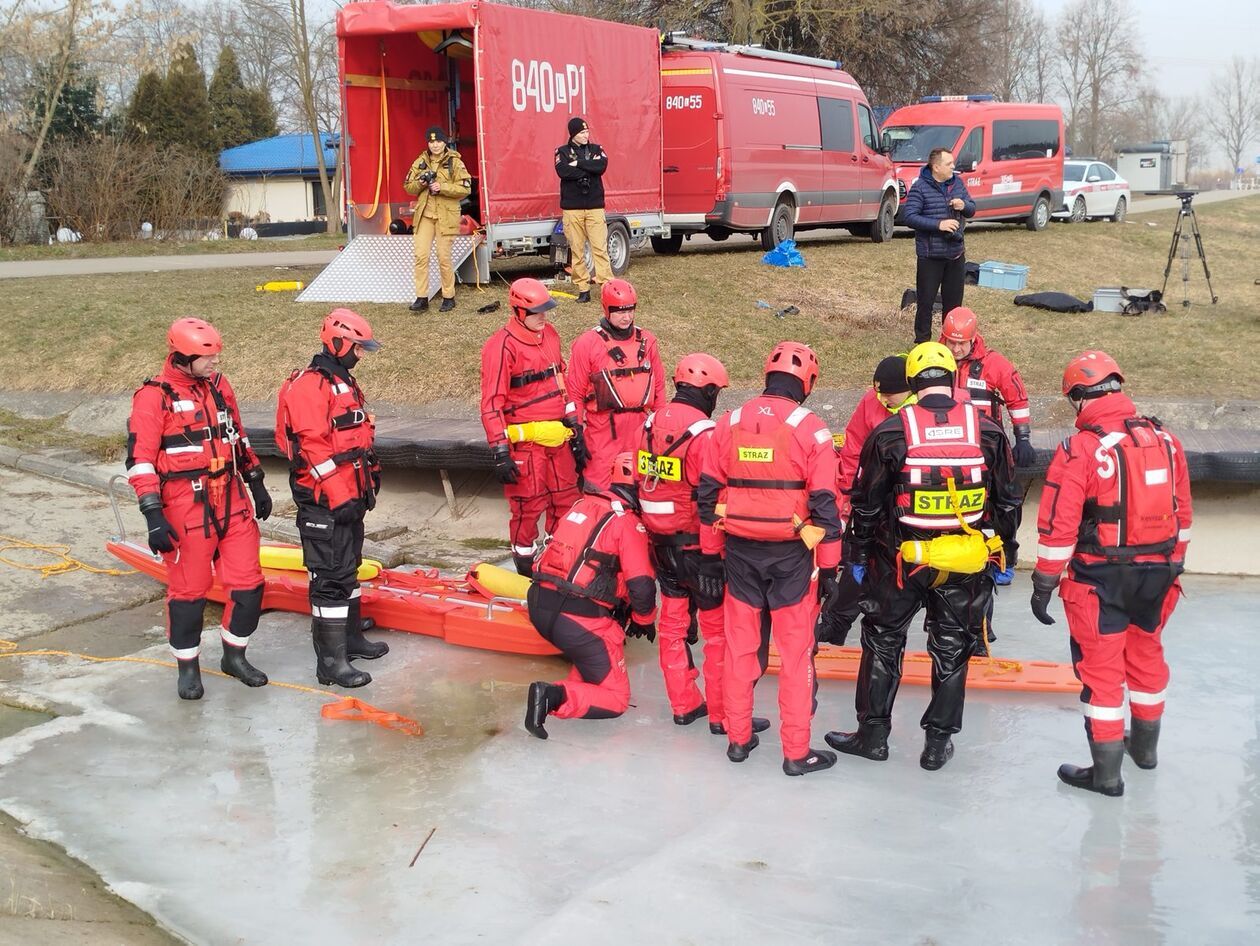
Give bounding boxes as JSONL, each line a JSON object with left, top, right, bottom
{"left": 402, "top": 125, "right": 473, "bottom": 312}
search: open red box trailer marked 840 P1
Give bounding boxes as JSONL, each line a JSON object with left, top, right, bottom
{"left": 336, "top": 3, "right": 668, "bottom": 272}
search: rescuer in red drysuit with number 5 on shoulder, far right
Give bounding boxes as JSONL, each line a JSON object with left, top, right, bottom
{"left": 1032, "top": 351, "right": 1192, "bottom": 795}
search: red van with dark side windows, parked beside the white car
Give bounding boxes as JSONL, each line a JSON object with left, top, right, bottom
{"left": 882, "top": 94, "right": 1063, "bottom": 231}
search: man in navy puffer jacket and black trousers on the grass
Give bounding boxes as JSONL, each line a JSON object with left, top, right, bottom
{"left": 902, "top": 147, "right": 975, "bottom": 345}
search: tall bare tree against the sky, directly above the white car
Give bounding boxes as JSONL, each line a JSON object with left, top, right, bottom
{"left": 1058, "top": 0, "right": 1142, "bottom": 156}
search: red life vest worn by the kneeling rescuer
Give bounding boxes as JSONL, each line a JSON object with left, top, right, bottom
{"left": 534, "top": 493, "right": 626, "bottom": 610}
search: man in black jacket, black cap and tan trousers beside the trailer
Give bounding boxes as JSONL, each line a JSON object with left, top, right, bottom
{"left": 556, "top": 118, "right": 612, "bottom": 302}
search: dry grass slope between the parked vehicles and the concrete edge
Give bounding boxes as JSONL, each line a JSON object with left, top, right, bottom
{"left": 0, "top": 197, "right": 1260, "bottom": 403}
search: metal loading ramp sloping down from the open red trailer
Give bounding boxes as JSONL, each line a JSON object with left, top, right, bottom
{"left": 297, "top": 233, "right": 490, "bottom": 305}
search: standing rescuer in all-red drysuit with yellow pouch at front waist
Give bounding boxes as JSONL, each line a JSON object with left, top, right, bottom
{"left": 481, "top": 278, "right": 587, "bottom": 577}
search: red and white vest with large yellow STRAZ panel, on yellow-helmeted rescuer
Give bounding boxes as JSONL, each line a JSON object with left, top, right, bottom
{"left": 893, "top": 402, "right": 989, "bottom": 532}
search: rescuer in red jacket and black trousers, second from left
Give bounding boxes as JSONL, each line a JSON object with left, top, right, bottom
{"left": 276, "top": 309, "right": 389, "bottom": 687}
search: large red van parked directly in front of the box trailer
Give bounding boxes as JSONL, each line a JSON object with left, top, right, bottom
{"left": 651, "top": 34, "right": 897, "bottom": 253}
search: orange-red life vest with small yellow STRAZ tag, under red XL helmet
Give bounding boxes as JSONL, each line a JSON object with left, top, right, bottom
{"left": 723, "top": 407, "right": 813, "bottom": 542}
